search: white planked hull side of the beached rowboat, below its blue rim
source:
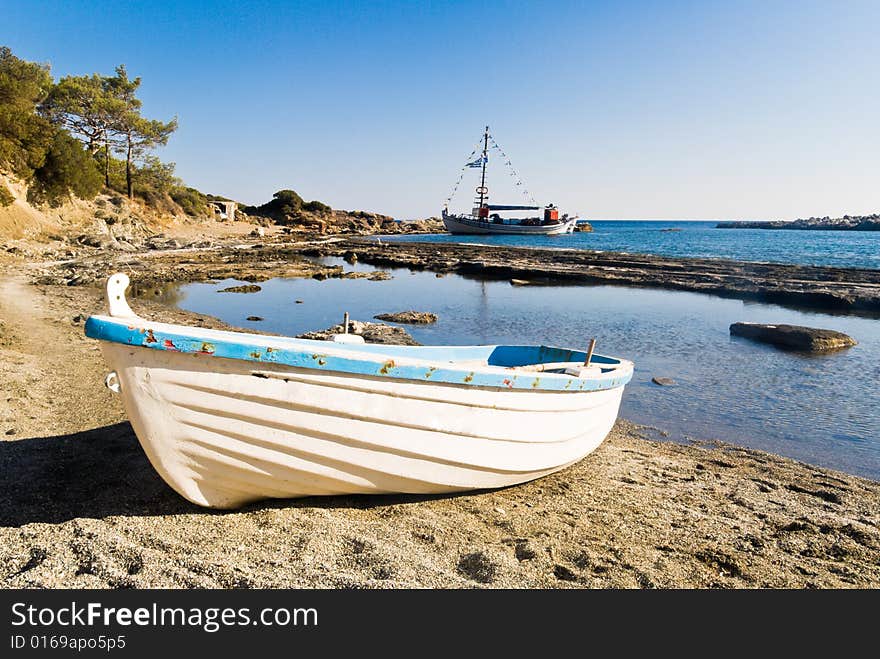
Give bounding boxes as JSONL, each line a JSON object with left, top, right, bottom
{"left": 101, "top": 342, "right": 623, "bottom": 508}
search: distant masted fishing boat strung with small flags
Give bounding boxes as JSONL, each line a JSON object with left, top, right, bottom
{"left": 441, "top": 126, "right": 578, "bottom": 236}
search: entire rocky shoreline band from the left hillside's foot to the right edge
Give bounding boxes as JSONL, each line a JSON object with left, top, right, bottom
{"left": 15, "top": 228, "right": 880, "bottom": 316}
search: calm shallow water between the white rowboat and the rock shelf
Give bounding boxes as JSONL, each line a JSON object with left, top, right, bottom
{"left": 155, "top": 255, "right": 880, "bottom": 480}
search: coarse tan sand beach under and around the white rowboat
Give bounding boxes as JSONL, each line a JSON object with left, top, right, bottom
{"left": 0, "top": 236, "right": 880, "bottom": 588}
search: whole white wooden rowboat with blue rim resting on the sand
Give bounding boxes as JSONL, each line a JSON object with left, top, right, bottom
{"left": 85, "top": 273, "right": 633, "bottom": 508}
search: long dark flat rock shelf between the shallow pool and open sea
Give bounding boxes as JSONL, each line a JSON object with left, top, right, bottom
{"left": 300, "top": 239, "right": 880, "bottom": 314}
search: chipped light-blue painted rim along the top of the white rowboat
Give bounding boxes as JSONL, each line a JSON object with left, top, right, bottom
{"left": 85, "top": 316, "right": 632, "bottom": 392}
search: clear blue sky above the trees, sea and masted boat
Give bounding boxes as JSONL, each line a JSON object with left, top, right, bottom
{"left": 6, "top": 0, "right": 880, "bottom": 218}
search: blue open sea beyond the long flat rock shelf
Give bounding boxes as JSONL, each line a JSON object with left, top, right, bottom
{"left": 382, "top": 220, "right": 880, "bottom": 269}
